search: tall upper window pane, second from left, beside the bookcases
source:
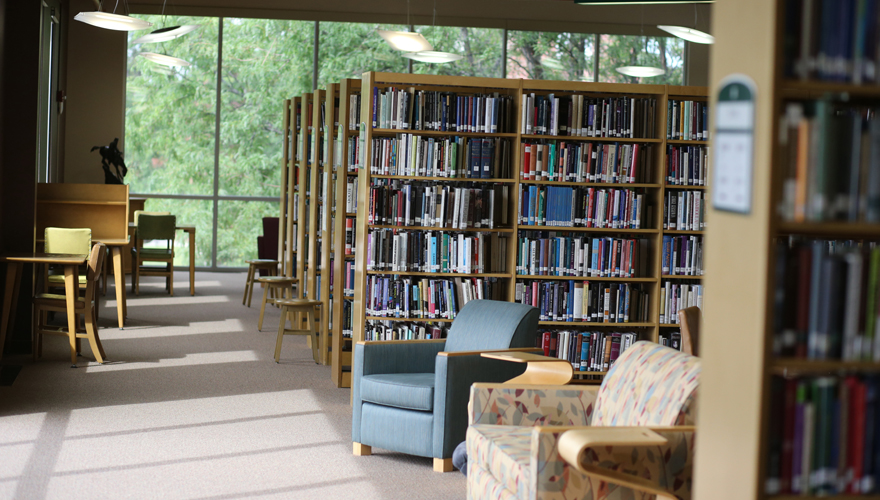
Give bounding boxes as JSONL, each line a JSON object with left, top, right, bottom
{"left": 220, "top": 19, "right": 315, "bottom": 196}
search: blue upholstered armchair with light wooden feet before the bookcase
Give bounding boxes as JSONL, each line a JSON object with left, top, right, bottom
{"left": 351, "top": 300, "right": 539, "bottom": 472}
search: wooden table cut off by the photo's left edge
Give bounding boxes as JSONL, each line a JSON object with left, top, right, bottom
{"left": 0, "top": 253, "right": 89, "bottom": 357}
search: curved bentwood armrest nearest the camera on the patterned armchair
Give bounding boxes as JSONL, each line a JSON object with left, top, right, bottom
{"left": 559, "top": 426, "right": 694, "bottom": 500}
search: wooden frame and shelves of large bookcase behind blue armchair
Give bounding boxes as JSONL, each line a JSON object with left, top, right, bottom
{"left": 344, "top": 73, "right": 708, "bottom": 376}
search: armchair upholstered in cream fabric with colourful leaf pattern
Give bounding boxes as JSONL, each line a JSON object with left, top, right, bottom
{"left": 467, "top": 342, "right": 700, "bottom": 500}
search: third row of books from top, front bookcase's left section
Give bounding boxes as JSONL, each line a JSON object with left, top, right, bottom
{"left": 367, "top": 180, "right": 510, "bottom": 229}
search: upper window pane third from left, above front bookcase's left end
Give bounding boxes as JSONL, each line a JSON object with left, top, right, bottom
{"left": 318, "top": 22, "right": 407, "bottom": 88}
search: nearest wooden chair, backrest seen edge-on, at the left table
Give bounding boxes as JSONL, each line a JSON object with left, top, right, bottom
{"left": 34, "top": 243, "right": 107, "bottom": 368}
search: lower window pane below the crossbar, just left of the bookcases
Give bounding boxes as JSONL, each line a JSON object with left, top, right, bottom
{"left": 217, "top": 200, "right": 279, "bottom": 267}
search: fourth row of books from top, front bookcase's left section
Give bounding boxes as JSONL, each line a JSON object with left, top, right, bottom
{"left": 367, "top": 229, "right": 508, "bottom": 274}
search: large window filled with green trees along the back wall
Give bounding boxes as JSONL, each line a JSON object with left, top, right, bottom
{"left": 125, "top": 16, "right": 684, "bottom": 268}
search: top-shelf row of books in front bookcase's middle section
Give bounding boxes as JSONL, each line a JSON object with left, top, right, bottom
{"left": 520, "top": 93, "right": 657, "bottom": 138}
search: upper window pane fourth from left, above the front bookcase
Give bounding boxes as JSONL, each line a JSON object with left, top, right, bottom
{"left": 413, "top": 26, "right": 503, "bottom": 78}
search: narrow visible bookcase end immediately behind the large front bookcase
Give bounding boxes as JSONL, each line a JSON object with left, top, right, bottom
{"left": 331, "top": 79, "right": 361, "bottom": 387}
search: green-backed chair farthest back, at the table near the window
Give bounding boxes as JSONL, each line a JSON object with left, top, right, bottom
{"left": 131, "top": 213, "right": 177, "bottom": 296}
